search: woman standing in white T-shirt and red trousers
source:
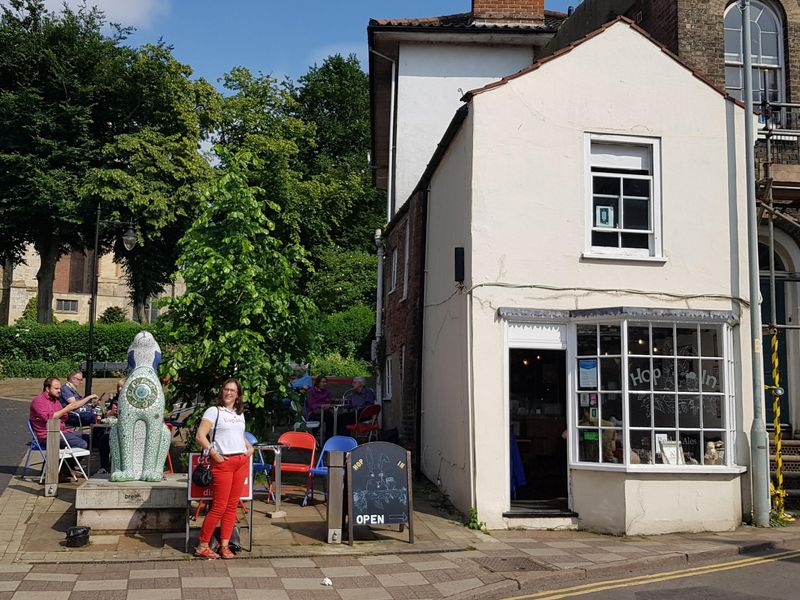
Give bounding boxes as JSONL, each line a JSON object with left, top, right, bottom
{"left": 194, "top": 379, "right": 253, "bottom": 558}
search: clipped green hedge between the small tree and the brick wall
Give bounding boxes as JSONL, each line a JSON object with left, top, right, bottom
{"left": 317, "top": 306, "right": 375, "bottom": 360}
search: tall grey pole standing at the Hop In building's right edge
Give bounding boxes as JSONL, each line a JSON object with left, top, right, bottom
{"left": 739, "top": 0, "right": 769, "bottom": 527}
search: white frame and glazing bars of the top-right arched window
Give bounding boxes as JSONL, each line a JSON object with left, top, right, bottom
{"left": 723, "top": 0, "right": 786, "bottom": 104}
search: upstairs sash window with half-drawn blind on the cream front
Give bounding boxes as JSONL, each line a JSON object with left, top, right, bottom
{"left": 587, "top": 134, "right": 661, "bottom": 257}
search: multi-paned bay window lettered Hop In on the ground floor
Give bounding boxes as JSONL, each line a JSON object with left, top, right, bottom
{"left": 575, "top": 321, "right": 733, "bottom": 468}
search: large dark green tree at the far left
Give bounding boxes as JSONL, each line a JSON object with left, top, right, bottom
{"left": 0, "top": 0, "right": 218, "bottom": 323}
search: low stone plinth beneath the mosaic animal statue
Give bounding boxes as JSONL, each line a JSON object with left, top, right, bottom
{"left": 75, "top": 474, "right": 187, "bottom": 532}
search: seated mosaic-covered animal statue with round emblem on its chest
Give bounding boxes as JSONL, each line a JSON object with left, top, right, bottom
{"left": 110, "top": 331, "right": 172, "bottom": 481}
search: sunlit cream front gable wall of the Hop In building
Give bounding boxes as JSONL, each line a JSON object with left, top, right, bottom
{"left": 425, "top": 24, "right": 752, "bottom": 527}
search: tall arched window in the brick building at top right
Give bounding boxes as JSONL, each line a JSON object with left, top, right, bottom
{"left": 725, "top": 0, "right": 785, "bottom": 103}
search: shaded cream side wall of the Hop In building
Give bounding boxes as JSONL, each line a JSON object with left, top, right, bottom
{"left": 421, "top": 117, "right": 472, "bottom": 514}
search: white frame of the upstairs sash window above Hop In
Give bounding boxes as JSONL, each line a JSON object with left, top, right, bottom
{"left": 583, "top": 133, "right": 665, "bottom": 262}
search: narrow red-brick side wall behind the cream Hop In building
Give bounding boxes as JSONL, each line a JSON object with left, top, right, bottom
{"left": 383, "top": 193, "right": 425, "bottom": 448}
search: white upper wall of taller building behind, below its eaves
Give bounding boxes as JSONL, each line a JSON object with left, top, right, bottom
{"left": 395, "top": 44, "right": 533, "bottom": 210}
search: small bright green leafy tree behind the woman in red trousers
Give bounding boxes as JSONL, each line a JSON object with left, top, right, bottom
{"left": 159, "top": 152, "right": 313, "bottom": 418}
